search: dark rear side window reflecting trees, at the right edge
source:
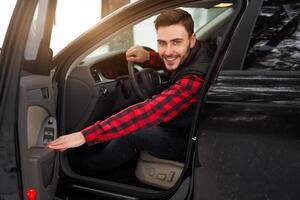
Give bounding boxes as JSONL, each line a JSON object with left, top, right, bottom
{"left": 242, "top": 1, "right": 300, "bottom": 71}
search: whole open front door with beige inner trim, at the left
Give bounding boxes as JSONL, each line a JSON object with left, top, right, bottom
{"left": 0, "top": 0, "right": 57, "bottom": 199}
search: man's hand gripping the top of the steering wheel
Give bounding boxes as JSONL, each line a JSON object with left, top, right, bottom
{"left": 126, "top": 45, "right": 150, "bottom": 63}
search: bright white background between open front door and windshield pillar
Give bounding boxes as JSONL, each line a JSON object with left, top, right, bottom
{"left": 50, "top": 0, "right": 136, "bottom": 55}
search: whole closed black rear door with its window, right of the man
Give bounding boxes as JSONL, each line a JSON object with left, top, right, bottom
{"left": 195, "top": 1, "right": 300, "bottom": 200}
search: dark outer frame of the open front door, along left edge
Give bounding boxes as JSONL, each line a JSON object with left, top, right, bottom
{"left": 0, "top": 0, "right": 54, "bottom": 199}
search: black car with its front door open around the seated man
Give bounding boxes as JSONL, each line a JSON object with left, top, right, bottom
{"left": 0, "top": 0, "right": 300, "bottom": 200}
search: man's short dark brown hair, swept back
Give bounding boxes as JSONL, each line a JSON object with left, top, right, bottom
{"left": 154, "top": 9, "right": 194, "bottom": 36}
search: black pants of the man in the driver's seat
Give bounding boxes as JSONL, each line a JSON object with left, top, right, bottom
{"left": 69, "top": 126, "right": 187, "bottom": 174}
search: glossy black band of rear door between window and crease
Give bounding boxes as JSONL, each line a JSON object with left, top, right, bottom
{"left": 207, "top": 73, "right": 300, "bottom": 108}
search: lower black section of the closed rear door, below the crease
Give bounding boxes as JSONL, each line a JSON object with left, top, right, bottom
{"left": 195, "top": 104, "right": 300, "bottom": 200}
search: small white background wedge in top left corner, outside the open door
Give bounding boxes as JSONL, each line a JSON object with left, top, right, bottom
{"left": 0, "top": 0, "right": 16, "bottom": 48}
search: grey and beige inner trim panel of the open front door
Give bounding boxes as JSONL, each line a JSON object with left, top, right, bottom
{"left": 18, "top": 75, "right": 58, "bottom": 199}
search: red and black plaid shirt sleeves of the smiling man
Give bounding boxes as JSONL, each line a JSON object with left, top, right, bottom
{"left": 81, "top": 52, "right": 203, "bottom": 145}
